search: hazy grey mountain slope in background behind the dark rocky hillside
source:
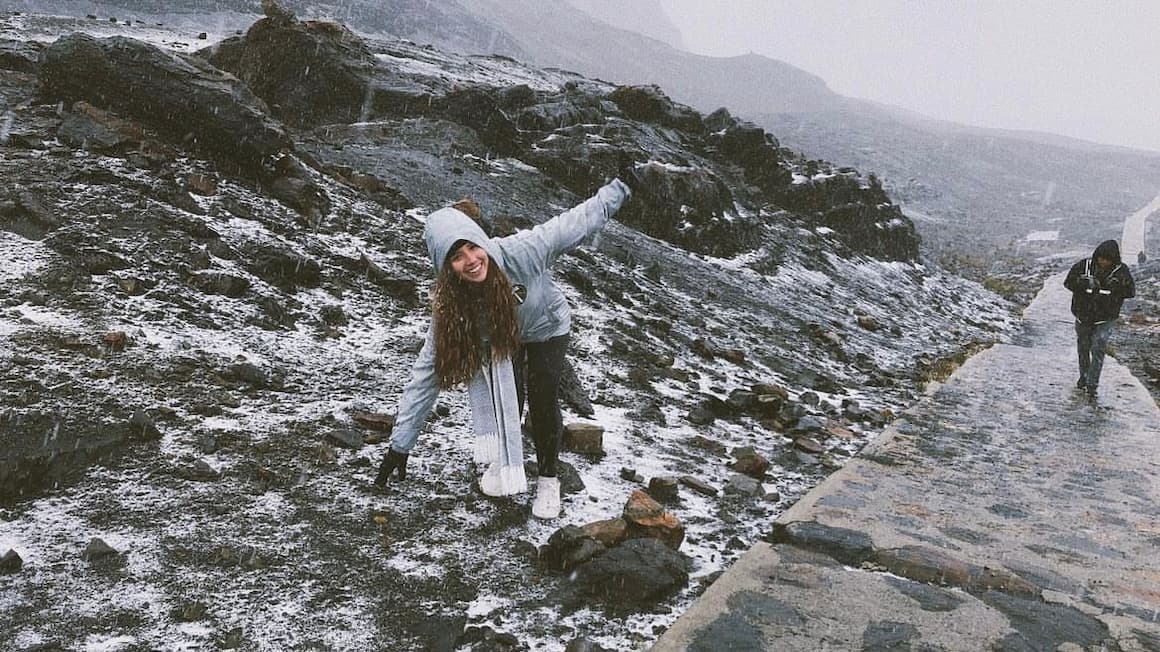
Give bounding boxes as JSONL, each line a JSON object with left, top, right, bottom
{"left": 11, "top": 0, "right": 1160, "bottom": 271}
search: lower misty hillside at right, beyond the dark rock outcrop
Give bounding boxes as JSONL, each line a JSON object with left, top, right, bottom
{"left": 754, "top": 108, "right": 1160, "bottom": 280}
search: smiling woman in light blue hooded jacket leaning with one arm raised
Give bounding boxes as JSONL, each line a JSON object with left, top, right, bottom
{"left": 375, "top": 180, "right": 631, "bottom": 519}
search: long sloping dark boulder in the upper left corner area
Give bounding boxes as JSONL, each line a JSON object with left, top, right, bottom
{"left": 39, "top": 34, "right": 292, "bottom": 176}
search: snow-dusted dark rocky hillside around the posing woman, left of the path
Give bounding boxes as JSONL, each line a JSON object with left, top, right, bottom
{"left": 0, "top": 8, "right": 1016, "bottom": 651}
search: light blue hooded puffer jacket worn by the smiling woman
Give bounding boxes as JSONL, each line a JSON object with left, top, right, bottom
{"left": 391, "top": 180, "right": 631, "bottom": 452}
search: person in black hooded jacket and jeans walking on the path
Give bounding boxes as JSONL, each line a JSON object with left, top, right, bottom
{"left": 1064, "top": 240, "right": 1136, "bottom": 394}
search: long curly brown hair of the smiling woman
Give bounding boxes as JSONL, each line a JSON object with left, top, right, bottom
{"left": 432, "top": 254, "right": 520, "bottom": 389}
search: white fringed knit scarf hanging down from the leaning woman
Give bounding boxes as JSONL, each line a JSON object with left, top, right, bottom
{"left": 467, "top": 357, "right": 528, "bottom": 495}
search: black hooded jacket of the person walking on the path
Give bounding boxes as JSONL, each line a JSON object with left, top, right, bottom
{"left": 1064, "top": 240, "right": 1136, "bottom": 324}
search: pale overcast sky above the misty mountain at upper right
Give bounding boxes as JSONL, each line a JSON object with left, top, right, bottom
{"left": 660, "top": 0, "right": 1160, "bottom": 151}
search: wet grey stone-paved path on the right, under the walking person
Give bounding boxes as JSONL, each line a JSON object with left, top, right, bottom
{"left": 653, "top": 212, "right": 1160, "bottom": 652}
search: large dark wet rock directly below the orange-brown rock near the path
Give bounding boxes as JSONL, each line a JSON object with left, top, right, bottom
{"left": 572, "top": 538, "right": 690, "bottom": 606}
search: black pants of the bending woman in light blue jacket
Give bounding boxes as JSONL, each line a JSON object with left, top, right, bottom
{"left": 515, "top": 334, "right": 570, "bottom": 478}
